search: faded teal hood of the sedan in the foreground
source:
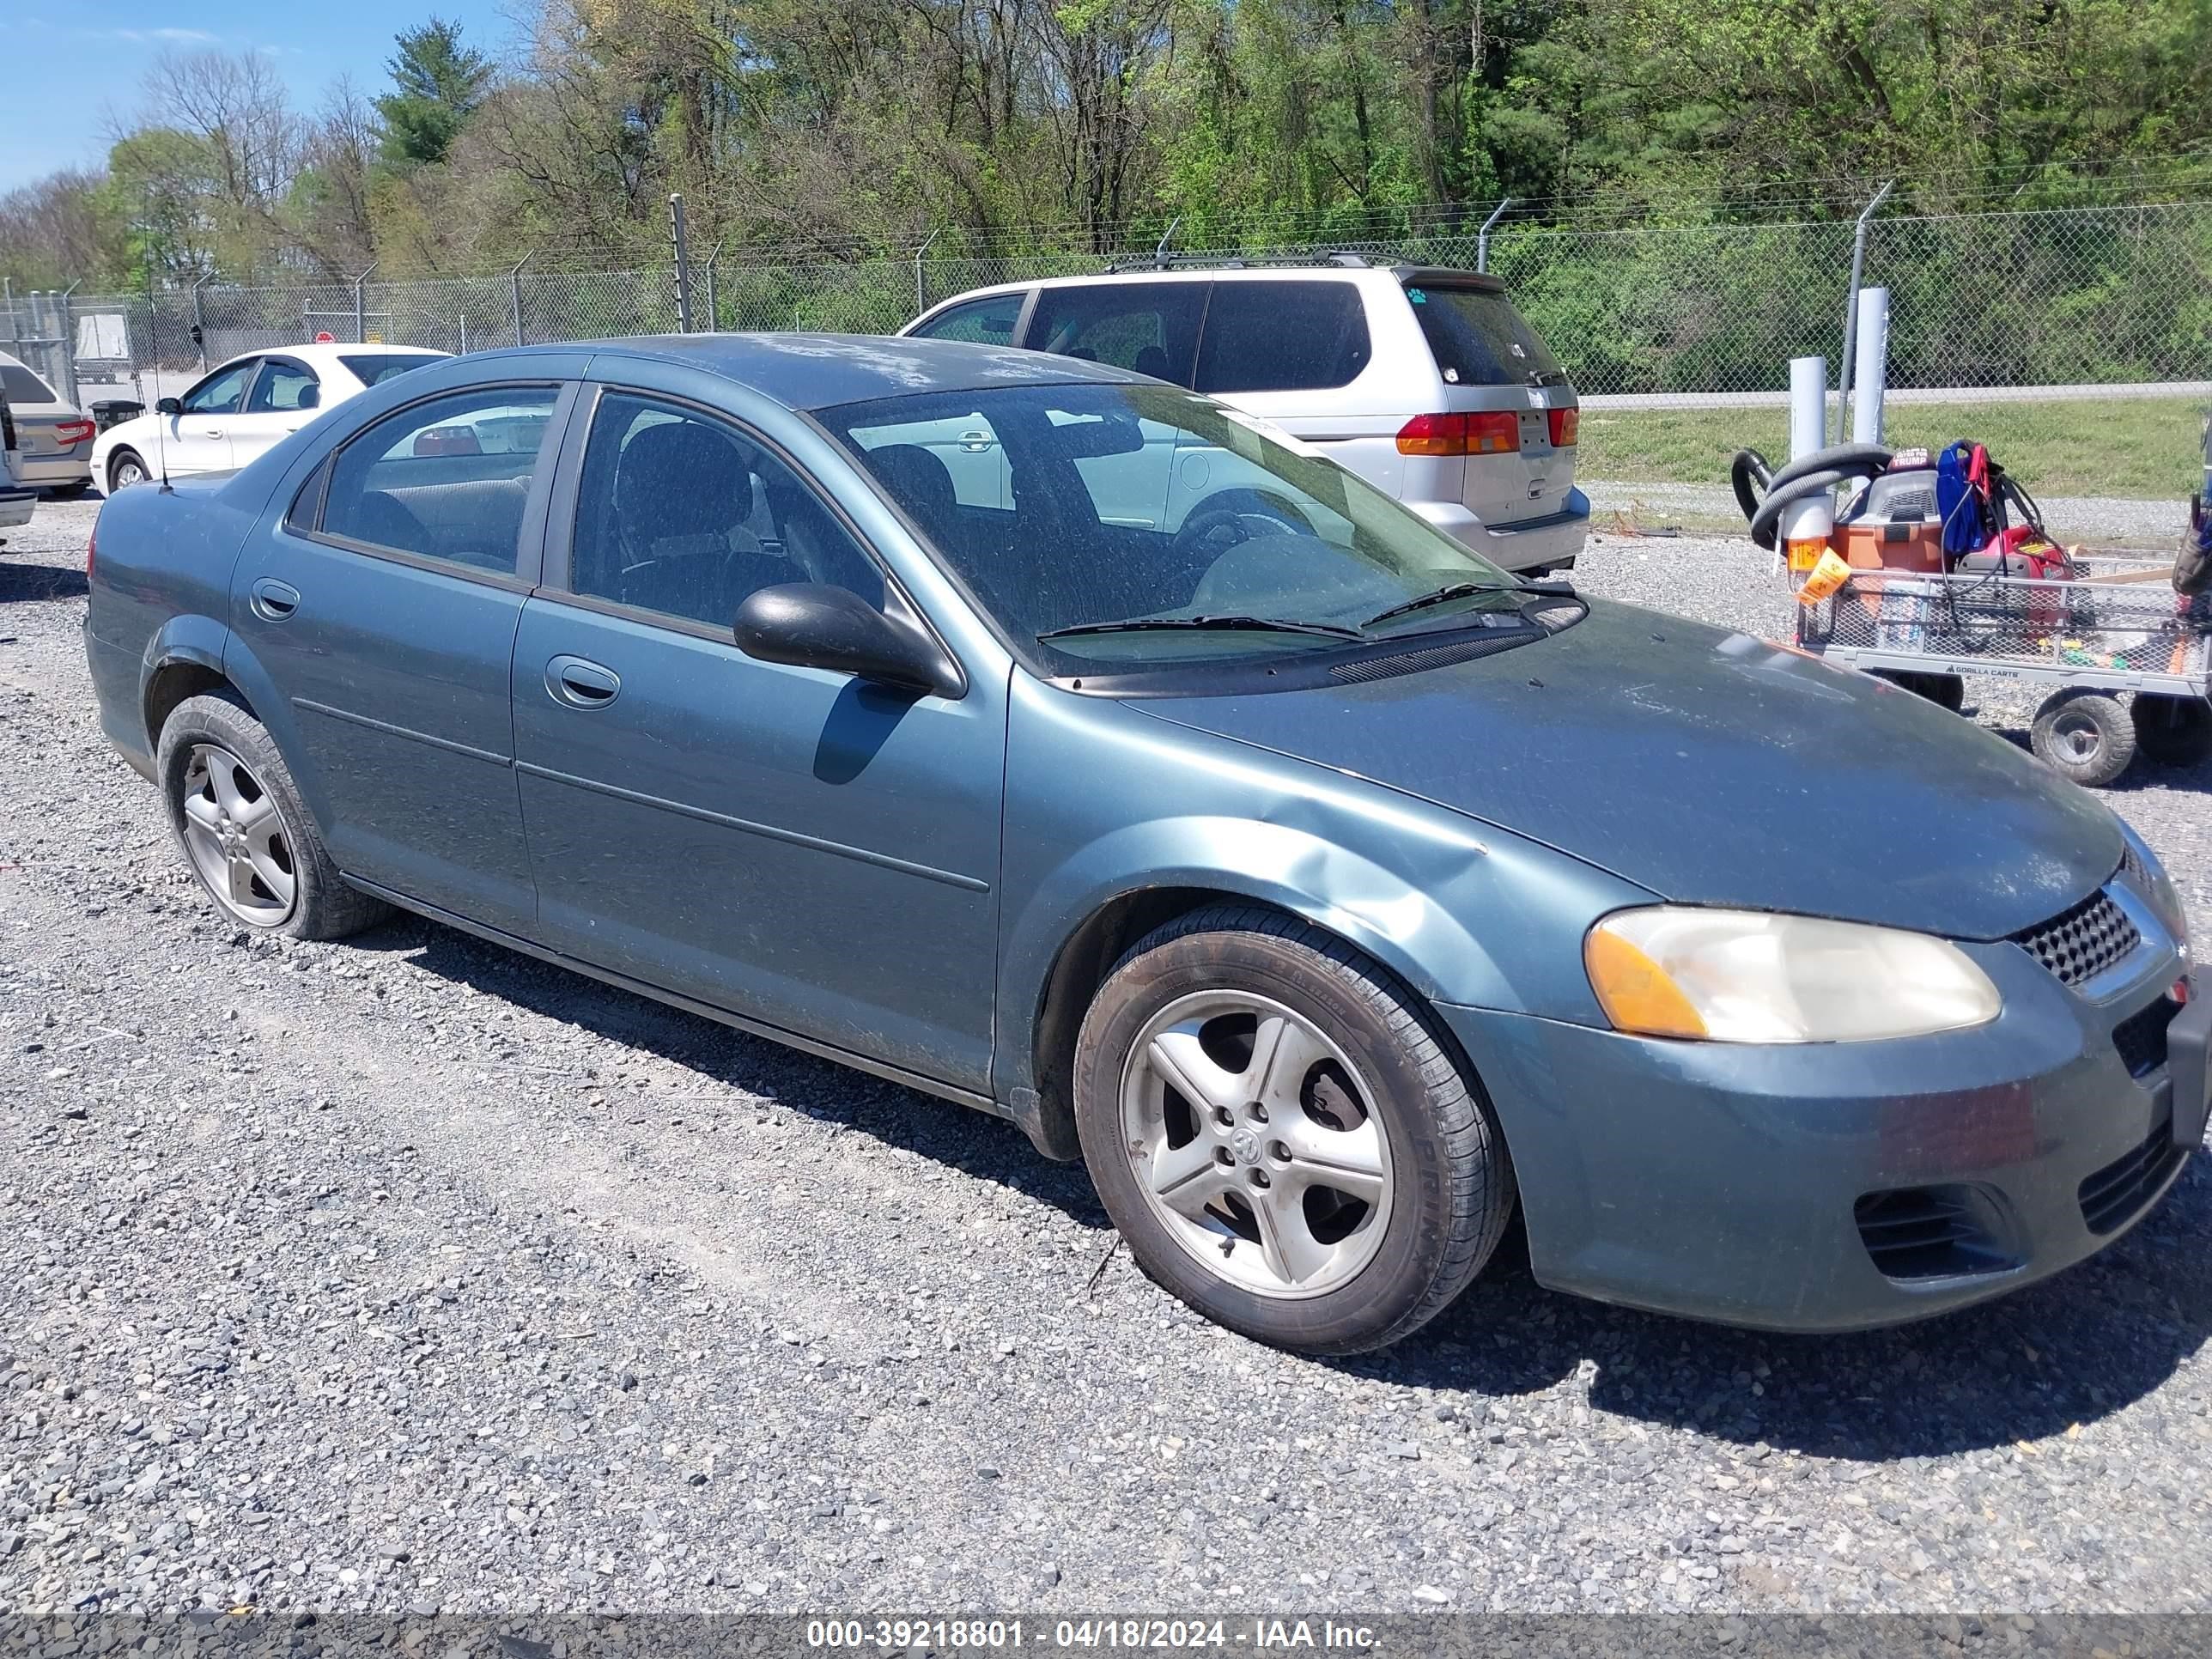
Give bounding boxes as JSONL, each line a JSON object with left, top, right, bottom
{"left": 1134, "top": 602, "right": 2121, "bottom": 938}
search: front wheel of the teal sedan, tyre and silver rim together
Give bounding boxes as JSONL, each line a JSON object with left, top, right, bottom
{"left": 1075, "top": 905, "right": 1513, "bottom": 1354}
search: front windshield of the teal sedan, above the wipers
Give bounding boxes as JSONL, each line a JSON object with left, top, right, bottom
{"left": 821, "top": 385, "right": 1526, "bottom": 675}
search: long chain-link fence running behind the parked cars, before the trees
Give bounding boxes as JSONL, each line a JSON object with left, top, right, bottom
{"left": 17, "top": 201, "right": 2212, "bottom": 413}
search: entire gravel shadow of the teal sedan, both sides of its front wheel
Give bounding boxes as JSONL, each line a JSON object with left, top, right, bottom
{"left": 354, "top": 918, "right": 2212, "bottom": 1460}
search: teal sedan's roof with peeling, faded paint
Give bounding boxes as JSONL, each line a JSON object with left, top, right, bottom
{"left": 483, "top": 334, "right": 1152, "bottom": 410}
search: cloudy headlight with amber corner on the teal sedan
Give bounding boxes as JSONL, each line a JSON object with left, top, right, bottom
{"left": 1582, "top": 905, "right": 2002, "bottom": 1042}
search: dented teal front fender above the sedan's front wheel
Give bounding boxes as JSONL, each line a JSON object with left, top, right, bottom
{"left": 995, "top": 675, "right": 1650, "bottom": 1099}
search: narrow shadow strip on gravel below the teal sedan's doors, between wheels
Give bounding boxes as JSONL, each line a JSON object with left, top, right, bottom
{"left": 371, "top": 915, "right": 1109, "bottom": 1249}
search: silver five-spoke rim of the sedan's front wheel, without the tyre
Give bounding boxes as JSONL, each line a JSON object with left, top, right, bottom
{"left": 1121, "top": 991, "right": 1391, "bottom": 1298}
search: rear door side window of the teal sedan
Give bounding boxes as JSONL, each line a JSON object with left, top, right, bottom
{"left": 323, "top": 387, "right": 557, "bottom": 575}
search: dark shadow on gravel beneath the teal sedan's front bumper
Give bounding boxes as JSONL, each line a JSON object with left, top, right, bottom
{"left": 1345, "top": 1157, "right": 2212, "bottom": 1458}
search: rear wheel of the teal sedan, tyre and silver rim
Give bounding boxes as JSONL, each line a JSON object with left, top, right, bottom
{"left": 155, "top": 692, "right": 385, "bottom": 938}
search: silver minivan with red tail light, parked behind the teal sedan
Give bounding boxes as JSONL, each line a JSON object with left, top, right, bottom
{"left": 900, "top": 254, "right": 1590, "bottom": 571}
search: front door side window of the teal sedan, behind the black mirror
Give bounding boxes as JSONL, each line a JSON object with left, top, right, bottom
{"left": 571, "top": 392, "right": 883, "bottom": 629}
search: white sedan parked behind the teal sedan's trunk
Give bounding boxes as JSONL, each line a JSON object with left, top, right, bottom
{"left": 93, "top": 345, "right": 452, "bottom": 495}
